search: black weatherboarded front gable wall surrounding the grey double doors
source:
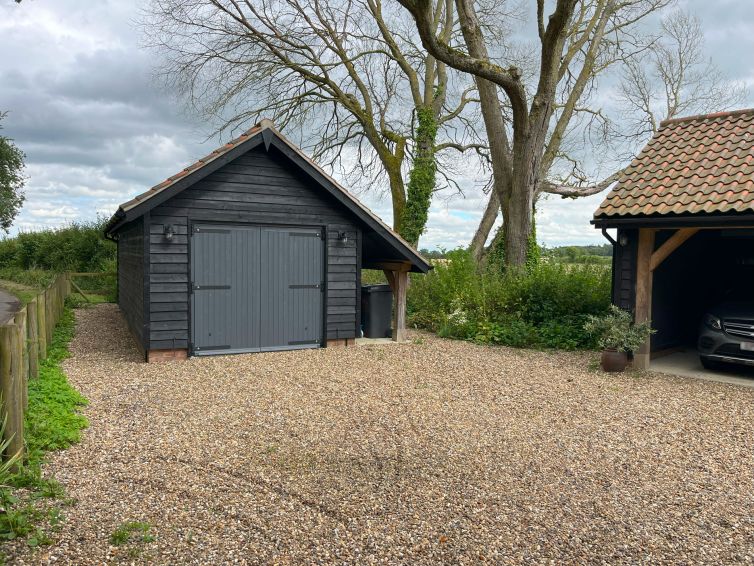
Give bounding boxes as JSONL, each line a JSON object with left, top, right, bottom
{"left": 149, "top": 146, "right": 361, "bottom": 350}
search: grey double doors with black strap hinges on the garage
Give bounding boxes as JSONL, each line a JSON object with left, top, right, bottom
{"left": 191, "top": 224, "right": 324, "bottom": 354}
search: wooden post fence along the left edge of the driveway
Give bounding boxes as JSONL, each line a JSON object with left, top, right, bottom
{"left": 0, "top": 273, "right": 71, "bottom": 462}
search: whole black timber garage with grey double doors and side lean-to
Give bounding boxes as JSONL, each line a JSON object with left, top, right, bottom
{"left": 105, "top": 120, "right": 431, "bottom": 360}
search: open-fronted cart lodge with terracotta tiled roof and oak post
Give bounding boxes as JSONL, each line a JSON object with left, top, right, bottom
{"left": 593, "top": 110, "right": 754, "bottom": 369}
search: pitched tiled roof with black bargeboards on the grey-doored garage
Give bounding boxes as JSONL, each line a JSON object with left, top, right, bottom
{"left": 104, "top": 120, "right": 432, "bottom": 273}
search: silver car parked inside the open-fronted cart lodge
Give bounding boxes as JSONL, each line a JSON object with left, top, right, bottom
{"left": 698, "top": 301, "right": 754, "bottom": 369}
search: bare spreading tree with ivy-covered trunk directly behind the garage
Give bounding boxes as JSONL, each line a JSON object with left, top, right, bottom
{"left": 147, "top": 0, "right": 482, "bottom": 244}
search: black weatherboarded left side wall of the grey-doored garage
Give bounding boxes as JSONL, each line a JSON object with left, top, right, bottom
{"left": 118, "top": 218, "right": 144, "bottom": 349}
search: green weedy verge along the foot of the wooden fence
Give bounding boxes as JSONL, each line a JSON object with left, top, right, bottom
{"left": 0, "top": 307, "right": 88, "bottom": 556}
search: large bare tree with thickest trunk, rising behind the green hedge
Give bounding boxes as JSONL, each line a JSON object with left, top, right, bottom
{"left": 399, "top": 0, "right": 668, "bottom": 266}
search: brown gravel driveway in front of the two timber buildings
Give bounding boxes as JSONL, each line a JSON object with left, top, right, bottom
{"left": 11, "top": 305, "right": 754, "bottom": 564}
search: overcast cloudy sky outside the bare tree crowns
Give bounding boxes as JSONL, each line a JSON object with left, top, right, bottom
{"left": 0, "top": 0, "right": 754, "bottom": 248}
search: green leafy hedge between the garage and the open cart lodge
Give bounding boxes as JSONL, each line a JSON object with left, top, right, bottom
{"left": 408, "top": 250, "right": 610, "bottom": 350}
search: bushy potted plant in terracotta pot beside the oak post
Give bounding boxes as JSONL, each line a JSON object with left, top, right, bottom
{"left": 584, "top": 305, "right": 655, "bottom": 372}
